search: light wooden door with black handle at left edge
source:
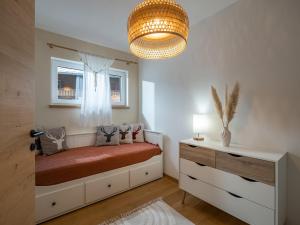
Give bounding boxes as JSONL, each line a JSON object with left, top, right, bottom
{"left": 0, "top": 0, "right": 35, "bottom": 225}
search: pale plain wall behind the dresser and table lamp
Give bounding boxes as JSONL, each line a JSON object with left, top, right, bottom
{"left": 140, "top": 0, "right": 300, "bottom": 225}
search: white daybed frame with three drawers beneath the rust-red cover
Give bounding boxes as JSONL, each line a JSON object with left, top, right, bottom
{"left": 35, "top": 130, "right": 163, "bottom": 223}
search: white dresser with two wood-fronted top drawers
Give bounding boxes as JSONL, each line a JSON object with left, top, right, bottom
{"left": 179, "top": 139, "right": 287, "bottom": 225}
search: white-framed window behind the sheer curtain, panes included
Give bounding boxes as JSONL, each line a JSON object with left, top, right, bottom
{"left": 51, "top": 57, "right": 128, "bottom": 106}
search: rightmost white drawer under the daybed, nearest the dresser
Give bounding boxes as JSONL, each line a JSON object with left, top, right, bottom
{"left": 130, "top": 161, "right": 163, "bottom": 187}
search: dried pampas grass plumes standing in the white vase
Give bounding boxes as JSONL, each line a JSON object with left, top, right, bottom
{"left": 211, "top": 82, "right": 240, "bottom": 127}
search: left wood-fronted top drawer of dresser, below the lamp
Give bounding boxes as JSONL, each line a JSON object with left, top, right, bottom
{"left": 180, "top": 143, "right": 216, "bottom": 167}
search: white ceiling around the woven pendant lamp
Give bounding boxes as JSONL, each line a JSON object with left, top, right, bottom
{"left": 35, "top": 0, "right": 237, "bottom": 51}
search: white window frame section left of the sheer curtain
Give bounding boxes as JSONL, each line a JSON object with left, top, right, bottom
{"left": 51, "top": 57, "right": 84, "bottom": 105}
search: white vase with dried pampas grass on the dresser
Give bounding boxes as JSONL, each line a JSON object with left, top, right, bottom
{"left": 211, "top": 83, "right": 240, "bottom": 147}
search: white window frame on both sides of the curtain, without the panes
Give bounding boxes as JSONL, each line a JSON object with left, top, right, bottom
{"left": 51, "top": 57, "right": 129, "bottom": 107}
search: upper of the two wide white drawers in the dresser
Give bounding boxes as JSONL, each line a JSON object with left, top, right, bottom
{"left": 180, "top": 159, "right": 275, "bottom": 209}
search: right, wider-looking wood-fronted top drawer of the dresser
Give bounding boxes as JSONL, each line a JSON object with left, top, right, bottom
{"left": 216, "top": 152, "right": 275, "bottom": 186}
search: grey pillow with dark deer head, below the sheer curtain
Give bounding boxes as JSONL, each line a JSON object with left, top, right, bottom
{"left": 96, "top": 126, "right": 120, "bottom": 146}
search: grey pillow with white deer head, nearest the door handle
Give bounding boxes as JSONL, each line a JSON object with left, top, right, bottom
{"left": 40, "top": 127, "right": 68, "bottom": 155}
